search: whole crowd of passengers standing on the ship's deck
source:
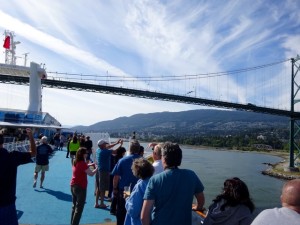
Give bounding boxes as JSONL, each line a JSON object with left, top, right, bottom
{"left": 0, "top": 129, "right": 300, "bottom": 225}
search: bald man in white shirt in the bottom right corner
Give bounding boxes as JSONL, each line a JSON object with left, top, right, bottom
{"left": 251, "top": 179, "right": 300, "bottom": 225}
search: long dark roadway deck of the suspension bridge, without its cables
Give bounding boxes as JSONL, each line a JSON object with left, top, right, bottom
{"left": 0, "top": 74, "right": 300, "bottom": 120}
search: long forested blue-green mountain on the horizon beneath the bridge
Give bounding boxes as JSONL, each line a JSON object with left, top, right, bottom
{"left": 72, "top": 109, "right": 289, "bottom": 135}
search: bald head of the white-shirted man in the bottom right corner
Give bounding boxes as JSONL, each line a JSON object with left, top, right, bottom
{"left": 281, "top": 179, "right": 300, "bottom": 213}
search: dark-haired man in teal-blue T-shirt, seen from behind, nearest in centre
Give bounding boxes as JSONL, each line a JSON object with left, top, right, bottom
{"left": 141, "top": 142, "right": 205, "bottom": 225}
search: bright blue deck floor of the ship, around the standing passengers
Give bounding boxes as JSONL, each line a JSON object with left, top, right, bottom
{"left": 16, "top": 150, "right": 116, "bottom": 225}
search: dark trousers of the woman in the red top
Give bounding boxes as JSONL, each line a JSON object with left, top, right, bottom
{"left": 71, "top": 185, "right": 86, "bottom": 225}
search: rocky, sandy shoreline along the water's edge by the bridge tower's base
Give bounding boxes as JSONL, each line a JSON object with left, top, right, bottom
{"left": 184, "top": 145, "right": 300, "bottom": 180}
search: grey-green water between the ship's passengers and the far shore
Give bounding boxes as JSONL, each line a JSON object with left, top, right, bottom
{"left": 142, "top": 143, "right": 284, "bottom": 214}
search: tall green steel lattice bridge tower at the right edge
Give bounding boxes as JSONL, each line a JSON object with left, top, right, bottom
{"left": 288, "top": 55, "right": 300, "bottom": 171}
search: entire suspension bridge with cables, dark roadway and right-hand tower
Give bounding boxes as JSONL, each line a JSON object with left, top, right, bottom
{"left": 0, "top": 56, "right": 300, "bottom": 168}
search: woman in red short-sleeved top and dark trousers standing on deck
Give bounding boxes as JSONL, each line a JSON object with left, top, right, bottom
{"left": 71, "top": 147, "right": 97, "bottom": 225}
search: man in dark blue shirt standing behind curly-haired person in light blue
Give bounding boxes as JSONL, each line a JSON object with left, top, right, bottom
{"left": 112, "top": 140, "right": 141, "bottom": 225}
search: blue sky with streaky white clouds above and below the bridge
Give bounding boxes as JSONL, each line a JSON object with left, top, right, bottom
{"left": 0, "top": 0, "right": 300, "bottom": 125}
